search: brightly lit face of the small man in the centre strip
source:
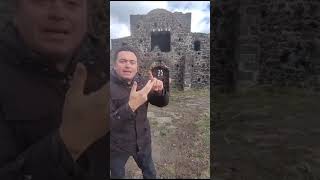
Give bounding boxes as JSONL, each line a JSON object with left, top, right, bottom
{"left": 114, "top": 51, "right": 138, "bottom": 81}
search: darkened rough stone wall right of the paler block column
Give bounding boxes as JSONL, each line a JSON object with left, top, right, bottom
{"left": 259, "top": 0, "right": 320, "bottom": 87}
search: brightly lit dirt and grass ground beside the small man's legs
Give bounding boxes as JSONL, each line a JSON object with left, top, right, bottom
{"left": 126, "top": 89, "right": 210, "bottom": 179}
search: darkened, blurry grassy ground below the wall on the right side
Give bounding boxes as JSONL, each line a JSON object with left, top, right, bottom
{"left": 211, "top": 86, "right": 320, "bottom": 180}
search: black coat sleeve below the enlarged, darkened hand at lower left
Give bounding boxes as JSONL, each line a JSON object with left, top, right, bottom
{"left": 0, "top": 108, "right": 102, "bottom": 180}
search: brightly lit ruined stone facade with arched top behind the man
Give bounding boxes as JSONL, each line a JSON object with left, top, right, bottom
{"left": 111, "top": 9, "right": 210, "bottom": 90}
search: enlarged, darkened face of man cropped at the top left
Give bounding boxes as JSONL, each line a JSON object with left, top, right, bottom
{"left": 15, "top": 0, "right": 87, "bottom": 57}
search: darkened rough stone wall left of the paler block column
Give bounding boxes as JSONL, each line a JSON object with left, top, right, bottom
{"left": 211, "top": 1, "right": 239, "bottom": 91}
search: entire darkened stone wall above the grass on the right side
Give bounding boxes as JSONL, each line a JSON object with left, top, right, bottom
{"left": 213, "top": 0, "right": 320, "bottom": 89}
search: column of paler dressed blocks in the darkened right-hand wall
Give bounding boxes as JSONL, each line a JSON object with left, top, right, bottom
{"left": 235, "top": 1, "right": 260, "bottom": 86}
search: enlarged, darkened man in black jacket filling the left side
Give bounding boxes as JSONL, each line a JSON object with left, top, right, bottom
{"left": 0, "top": 0, "right": 109, "bottom": 180}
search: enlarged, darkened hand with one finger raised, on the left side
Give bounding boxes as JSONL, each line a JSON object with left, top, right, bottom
{"left": 59, "top": 63, "right": 109, "bottom": 160}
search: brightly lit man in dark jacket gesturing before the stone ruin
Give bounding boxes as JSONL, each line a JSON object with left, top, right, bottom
{"left": 110, "top": 46, "right": 169, "bottom": 179}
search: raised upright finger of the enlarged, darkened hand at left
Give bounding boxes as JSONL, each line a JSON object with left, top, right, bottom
{"left": 69, "top": 63, "right": 87, "bottom": 94}
